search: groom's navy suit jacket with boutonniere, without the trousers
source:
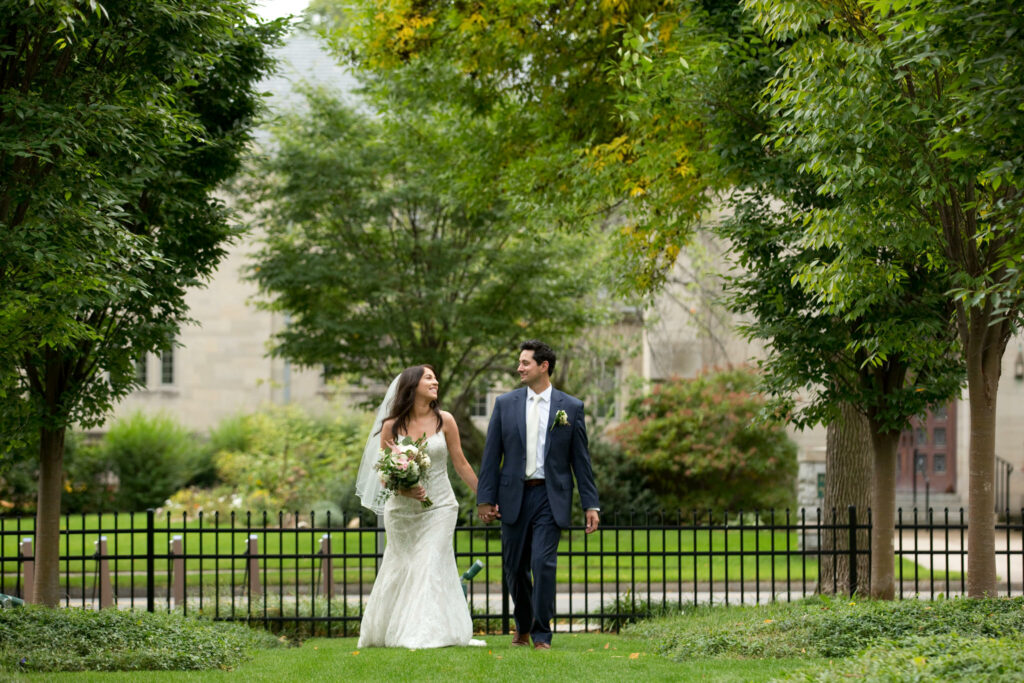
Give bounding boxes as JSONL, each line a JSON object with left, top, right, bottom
{"left": 476, "top": 387, "right": 600, "bottom": 528}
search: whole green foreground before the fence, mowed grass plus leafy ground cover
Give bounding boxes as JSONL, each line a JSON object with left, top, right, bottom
{"left": 8, "top": 596, "right": 1024, "bottom": 683}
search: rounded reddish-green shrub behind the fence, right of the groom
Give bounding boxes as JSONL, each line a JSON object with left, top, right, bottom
{"left": 611, "top": 370, "right": 797, "bottom": 510}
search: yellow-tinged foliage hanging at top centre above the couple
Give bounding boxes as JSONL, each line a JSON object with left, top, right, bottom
{"left": 316, "top": 0, "right": 736, "bottom": 293}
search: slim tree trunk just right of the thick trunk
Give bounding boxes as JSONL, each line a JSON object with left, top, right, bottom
{"left": 870, "top": 422, "right": 899, "bottom": 600}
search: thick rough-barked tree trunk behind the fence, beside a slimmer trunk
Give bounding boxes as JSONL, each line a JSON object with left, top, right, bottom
{"left": 818, "top": 402, "right": 874, "bottom": 595}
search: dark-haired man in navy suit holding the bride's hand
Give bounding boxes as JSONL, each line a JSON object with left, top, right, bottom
{"left": 476, "top": 340, "right": 599, "bottom": 650}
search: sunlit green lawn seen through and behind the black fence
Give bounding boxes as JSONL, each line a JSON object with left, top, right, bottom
{"left": 0, "top": 513, "right": 962, "bottom": 594}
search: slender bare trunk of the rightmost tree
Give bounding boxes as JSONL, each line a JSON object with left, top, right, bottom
{"left": 967, "top": 344, "right": 1006, "bottom": 598}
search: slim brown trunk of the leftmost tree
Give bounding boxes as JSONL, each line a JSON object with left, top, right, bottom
{"left": 32, "top": 427, "right": 66, "bottom": 607}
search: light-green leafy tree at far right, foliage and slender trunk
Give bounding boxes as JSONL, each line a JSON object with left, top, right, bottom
{"left": 750, "top": 0, "right": 1024, "bottom": 597}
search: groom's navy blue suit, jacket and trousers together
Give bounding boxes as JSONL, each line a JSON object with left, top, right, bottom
{"left": 476, "top": 387, "right": 599, "bottom": 643}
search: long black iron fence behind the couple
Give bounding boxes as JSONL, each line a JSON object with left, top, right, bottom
{"left": 0, "top": 508, "right": 1024, "bottom": 636}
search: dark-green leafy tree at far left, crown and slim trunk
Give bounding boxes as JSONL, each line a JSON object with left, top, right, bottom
{"left": 0, "top": 0, "right": 283, "bottom": 605}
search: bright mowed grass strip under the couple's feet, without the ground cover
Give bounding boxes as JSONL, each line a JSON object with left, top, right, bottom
{"left": 14, "top": 634, "right": 816, "bottom": 683}
